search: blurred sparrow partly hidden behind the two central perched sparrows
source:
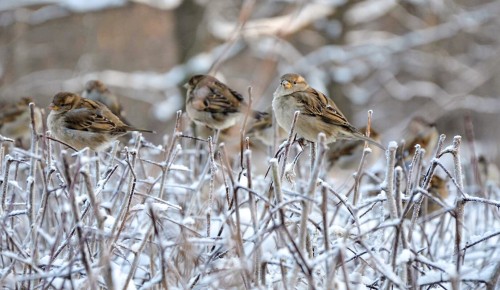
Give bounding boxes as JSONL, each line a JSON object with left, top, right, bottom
{"left": 248, "top": 107, "right": 287, "bottom": 146}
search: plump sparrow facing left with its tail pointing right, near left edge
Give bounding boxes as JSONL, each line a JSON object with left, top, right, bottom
{"left": 47, "top": 92, "right": 154, "bottom": 151}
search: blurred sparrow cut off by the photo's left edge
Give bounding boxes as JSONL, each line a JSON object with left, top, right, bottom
{"left": 0, "top": 97, "right": 42, "bottom": 147}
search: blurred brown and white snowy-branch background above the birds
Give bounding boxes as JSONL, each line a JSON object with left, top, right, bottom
{"left": 0, "top": 0, "right": 500, "bottom": 168}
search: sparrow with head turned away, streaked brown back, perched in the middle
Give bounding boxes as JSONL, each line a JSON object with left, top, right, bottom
{"left": 184, "top": 75, "right": 249, "bottom": 130}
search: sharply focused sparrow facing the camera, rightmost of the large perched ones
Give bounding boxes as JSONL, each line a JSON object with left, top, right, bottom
{"left": 273, "top": 73, "right": 385, "bottom": 150}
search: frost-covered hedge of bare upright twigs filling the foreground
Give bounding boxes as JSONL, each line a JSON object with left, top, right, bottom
{"left": 0, "top": 101, "right": 500, "bottom": 289}
